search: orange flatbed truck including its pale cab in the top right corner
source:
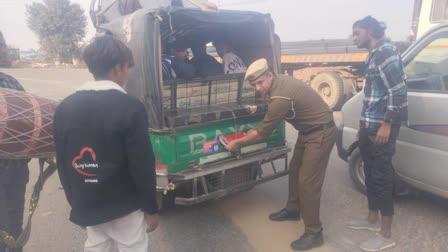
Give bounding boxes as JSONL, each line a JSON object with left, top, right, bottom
{"left": 281, "top": 0, "right": 448, "bottom": 110}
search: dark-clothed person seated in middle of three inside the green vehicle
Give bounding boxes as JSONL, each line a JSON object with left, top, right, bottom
{"left": 190, "top": 43, "right": 222, "bottom": 77}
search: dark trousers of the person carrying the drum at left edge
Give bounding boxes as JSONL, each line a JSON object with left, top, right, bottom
{"left": 0, "top": 160, "right": 29, "bottom": 252}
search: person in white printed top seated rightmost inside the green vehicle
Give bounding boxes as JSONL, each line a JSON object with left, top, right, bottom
{"left": 213, "top": 40, "right": 247, "bottom": 74}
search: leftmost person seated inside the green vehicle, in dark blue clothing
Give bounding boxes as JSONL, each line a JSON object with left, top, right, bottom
{"left": 162, "top": 44, "right": 195, "bottom": 81}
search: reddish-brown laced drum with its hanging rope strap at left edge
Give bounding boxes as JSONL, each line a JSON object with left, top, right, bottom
{"left": 0, "top": 88, "right": 58, "bottom": 248}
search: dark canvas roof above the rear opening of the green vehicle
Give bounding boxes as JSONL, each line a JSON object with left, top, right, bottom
{"left": 158, "top": 7, "right": 274, "bottom": 46}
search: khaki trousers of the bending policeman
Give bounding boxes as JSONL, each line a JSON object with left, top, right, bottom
{"left": 286, "top": 126, "right": 337, "bottom": 233}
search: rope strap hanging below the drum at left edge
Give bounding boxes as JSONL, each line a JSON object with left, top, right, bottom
{"left": 0, "top": 159, "right": 56, "bottom": 248}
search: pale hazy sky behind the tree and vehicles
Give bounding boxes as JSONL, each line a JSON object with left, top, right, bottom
{"left": 0, "top": 0, "right": 414, "bottom": 50}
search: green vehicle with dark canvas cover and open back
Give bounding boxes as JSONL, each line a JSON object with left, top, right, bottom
{"left": 91, "top": 1, "right": 289, "bottom": 207}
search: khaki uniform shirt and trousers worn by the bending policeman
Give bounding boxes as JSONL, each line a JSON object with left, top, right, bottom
{"left": 257, "top": 75, "right": 337, "bottom": 233}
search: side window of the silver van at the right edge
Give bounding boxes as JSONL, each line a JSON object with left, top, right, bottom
{"left": 406, "top": 38, "right": 448, "bottom": 92}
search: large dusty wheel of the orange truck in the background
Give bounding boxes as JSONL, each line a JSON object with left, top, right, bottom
{"left": 311, "top": 72, "right": 345, "bottom": 110}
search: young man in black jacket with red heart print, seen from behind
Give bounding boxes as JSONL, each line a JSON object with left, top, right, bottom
{"left": 54, "top": 35, "right": 159, "bottom": 252}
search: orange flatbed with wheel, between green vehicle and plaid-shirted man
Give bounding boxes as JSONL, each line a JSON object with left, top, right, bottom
{"left": 281, "top": 39, "right": 368, "bottom": 110}
